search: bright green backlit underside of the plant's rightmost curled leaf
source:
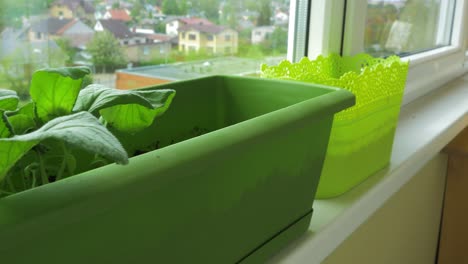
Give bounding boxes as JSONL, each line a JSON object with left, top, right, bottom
{"left": 100, "top": 90, "right": 175, "bottom": 133}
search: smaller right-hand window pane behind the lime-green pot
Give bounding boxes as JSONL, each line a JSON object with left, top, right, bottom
{"left": 364, "top": 0, "right": 455, "bottom": 56}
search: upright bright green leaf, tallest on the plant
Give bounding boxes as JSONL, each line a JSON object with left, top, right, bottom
{"left": 30, "top": 67, "right": 90, "bottom": 122}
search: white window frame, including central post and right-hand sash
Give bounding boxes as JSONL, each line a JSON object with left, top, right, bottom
{"left": 298, "top": 0, "right": 468, "bottom": 104}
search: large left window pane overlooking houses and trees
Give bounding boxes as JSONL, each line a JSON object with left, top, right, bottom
{"left": 0, "top": 0, "right": 291, "bottom": 93}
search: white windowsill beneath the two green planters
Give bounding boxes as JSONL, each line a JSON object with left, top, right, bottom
{"left": 270, "top": 74, "right": 468, "bottom": 264}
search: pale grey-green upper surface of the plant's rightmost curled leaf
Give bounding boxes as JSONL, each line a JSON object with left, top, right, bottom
{"left": 73, "top": 84, "right": 153, "bottom": 114}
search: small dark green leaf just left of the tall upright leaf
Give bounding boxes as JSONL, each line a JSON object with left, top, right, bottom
{"left": 7, "top": 102, "right": 36, "bottom": 135}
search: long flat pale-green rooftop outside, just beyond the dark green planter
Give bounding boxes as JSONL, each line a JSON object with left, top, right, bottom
{"left": 119, "top": 57, "right": 284, "bottom": 81}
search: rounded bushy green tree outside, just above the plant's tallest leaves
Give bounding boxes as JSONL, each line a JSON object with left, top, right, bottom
{"left": 86, "top": 31, "right": 127, "bottom": 72}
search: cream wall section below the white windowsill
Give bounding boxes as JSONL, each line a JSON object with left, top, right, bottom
{"left": 323, "top": 154, "right": 447, "bottom": 264}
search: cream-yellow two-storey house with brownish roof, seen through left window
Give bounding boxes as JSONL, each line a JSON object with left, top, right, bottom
{"left": 178, "top": 24, "right": 238, "bottom": 55}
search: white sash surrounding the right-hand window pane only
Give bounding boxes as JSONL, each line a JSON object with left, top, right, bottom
{"left": 336, "top": 0, "right": 468, "bottom": 104}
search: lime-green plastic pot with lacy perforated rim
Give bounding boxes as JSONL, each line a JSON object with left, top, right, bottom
{"left": 262, "top": 54, "right": 408, "bottom": 198}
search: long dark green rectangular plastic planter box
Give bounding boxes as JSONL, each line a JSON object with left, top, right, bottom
{"left": 0, "top": 76, "right": 354, "bottom": 264}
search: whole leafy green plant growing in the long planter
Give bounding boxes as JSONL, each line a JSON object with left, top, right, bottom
{"left": 0, "top": 67, "right": 175, "bottom": 195}
